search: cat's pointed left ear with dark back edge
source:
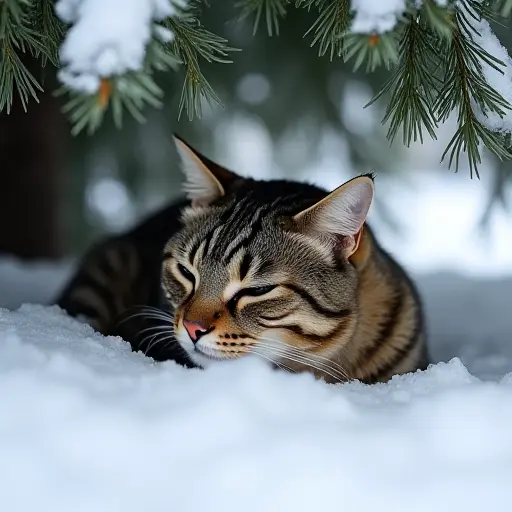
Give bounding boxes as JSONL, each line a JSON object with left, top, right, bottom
{"left": 173, "top": 135, "right": 240, "bottom": 206}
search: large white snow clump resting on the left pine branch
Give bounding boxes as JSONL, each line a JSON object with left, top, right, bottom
{"left": 55, "top": 0, "right": 182, "bottom": 94}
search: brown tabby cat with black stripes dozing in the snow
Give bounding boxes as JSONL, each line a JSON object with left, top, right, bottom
{"left": 58, "top": 137, "right": 428, "bottom": 383}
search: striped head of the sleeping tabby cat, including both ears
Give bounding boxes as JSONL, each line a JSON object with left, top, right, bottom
{"left": 162, "top": 139, "right": 373, "bottom": 376}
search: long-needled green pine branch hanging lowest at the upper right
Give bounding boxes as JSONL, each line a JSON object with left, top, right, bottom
{"left": 346, "top": 0, "right": 512, "bottom": 176}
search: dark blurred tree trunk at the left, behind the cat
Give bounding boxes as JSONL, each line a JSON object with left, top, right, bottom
{"left": 0, "top": 68, "right": 65, "bottom": 259}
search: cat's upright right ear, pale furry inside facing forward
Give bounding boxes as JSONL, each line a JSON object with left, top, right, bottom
{"left": 293, "top": 175, "right": 373, "bottom": 258}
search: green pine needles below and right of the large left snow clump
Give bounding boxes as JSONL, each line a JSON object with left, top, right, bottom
{"left": 55, "top": 4, "right": 238, "bottom": 134}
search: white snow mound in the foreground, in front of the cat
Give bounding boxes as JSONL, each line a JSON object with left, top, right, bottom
{"left": 0, "top": 305, "right": 512, "bottom": 512}
